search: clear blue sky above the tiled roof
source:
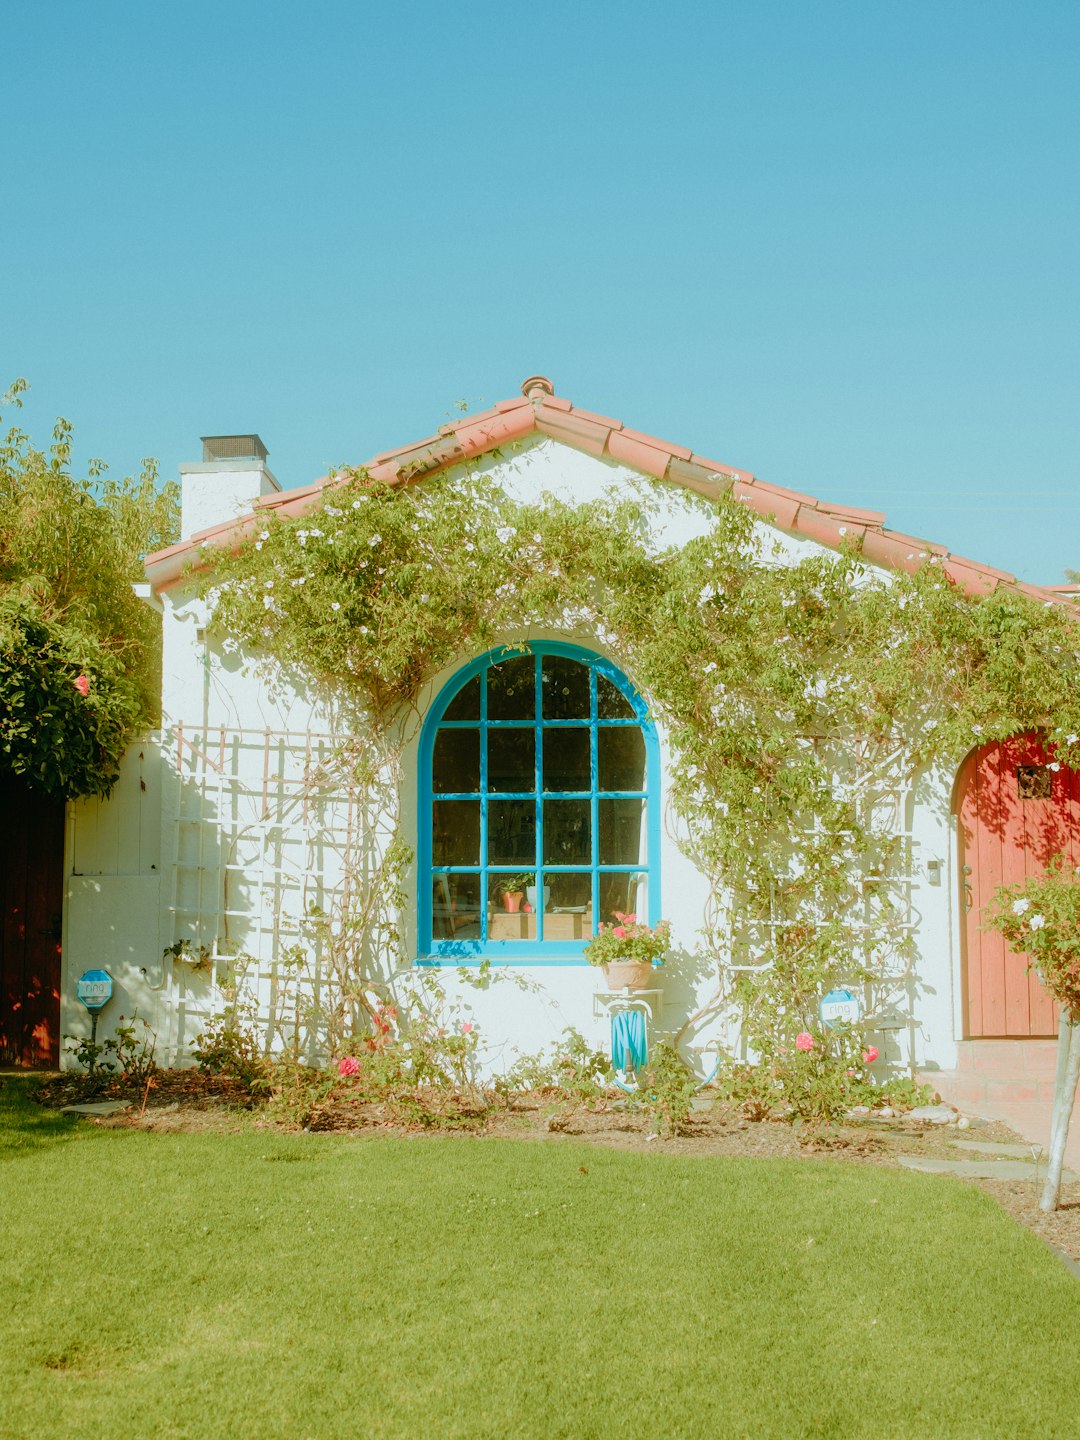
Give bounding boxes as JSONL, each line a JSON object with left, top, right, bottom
{"left": 0, "top": 0, "right": 1080, "bottom": 582}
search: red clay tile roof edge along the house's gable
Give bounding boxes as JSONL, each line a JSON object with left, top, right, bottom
{"left": 145, "top": 376, "right": 1076, "bottom": 609}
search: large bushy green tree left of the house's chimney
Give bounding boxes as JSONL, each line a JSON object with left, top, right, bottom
{"left": 0, "top": 380, "right": 179, "bottom": 799}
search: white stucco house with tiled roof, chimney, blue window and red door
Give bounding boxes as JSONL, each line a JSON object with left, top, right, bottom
{"left": 60, "top": 377, "right": 1080, "bottom": 1070}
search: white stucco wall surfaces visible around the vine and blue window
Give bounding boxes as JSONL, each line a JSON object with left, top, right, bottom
{"left": 63, "top": 439, "right": 959, "bottom": 1068}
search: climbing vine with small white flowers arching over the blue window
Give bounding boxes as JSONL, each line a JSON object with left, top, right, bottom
{"left": 204, "top": 460, "right": 1080, "bottom": 1071}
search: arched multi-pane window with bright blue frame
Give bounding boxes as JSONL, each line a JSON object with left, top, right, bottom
{"left": 419, "top": 642, "right": 660, "bottom": 965}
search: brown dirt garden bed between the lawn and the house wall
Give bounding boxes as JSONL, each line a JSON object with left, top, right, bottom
{"left": 25, "top": 1070, "right": 1080, "bottom": 1264}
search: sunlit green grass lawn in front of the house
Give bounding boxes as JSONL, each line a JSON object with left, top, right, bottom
{"left": 0, "top": 1084, "right": 1080, "bottom": 1440}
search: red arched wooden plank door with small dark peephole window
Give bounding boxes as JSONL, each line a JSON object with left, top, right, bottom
{"left": 956, "top": 736, "right": 1080, "bottom": 1038}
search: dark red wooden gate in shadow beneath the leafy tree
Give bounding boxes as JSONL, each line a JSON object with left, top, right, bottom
{"left": 0, "top": 778, "right": 63, "bottom": 1066}
